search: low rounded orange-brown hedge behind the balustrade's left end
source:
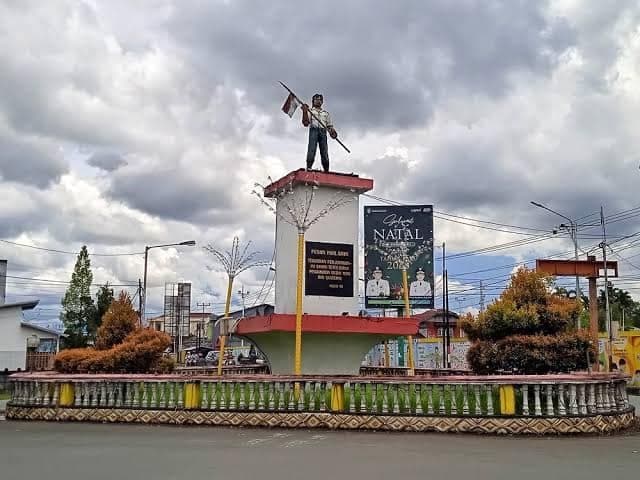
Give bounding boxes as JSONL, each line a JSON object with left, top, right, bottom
{"left": 54, "top": 329, "right": 173, "bottom": 373}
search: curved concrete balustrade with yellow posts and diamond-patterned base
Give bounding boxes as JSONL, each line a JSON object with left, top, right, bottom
{"left": 6, "top": 373, "right": 634, "bottom": 434}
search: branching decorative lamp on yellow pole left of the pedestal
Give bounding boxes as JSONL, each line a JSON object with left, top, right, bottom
{"left": 204, "top": 237, "right": 271, "bottom": 375}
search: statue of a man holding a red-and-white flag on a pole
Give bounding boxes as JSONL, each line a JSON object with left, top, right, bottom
{"left": 280, "top": 82, "right": 349, "bottom": 172}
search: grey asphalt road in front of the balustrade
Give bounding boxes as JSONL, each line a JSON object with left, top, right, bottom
{"left": 0, "top": 421, "right": 640, "bottom": 480}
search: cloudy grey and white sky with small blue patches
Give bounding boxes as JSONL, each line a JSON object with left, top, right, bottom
{"left": 0, "top": 0, "right": 640, "bottom": 321}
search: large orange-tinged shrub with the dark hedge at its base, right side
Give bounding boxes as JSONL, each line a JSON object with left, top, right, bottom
{"left": 462, "top": 268, "right": 594, "bottom": 374}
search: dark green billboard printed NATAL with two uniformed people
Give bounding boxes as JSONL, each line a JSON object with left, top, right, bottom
{"left": 364, "top": 205, "right": 434, "bottom": 308}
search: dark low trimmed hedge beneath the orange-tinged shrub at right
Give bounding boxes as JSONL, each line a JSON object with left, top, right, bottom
{"left": 467, "top": 331, "right": 595, "bottom": 375}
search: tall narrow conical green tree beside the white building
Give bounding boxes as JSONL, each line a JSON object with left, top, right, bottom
{"left": 60, "top": 245, "right": 96, "bottom": 348}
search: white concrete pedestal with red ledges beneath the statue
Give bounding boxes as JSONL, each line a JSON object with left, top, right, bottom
{"left": 244, "top": 169, "right": 418, "bottom": 375}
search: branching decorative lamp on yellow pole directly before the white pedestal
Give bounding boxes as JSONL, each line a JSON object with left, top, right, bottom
{"left": 251, "top": 182, "right": 357, "bottom": 375}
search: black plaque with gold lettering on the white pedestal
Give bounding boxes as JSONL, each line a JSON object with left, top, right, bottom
{"left": 304, "top": 242, "right": 353, "bottom": 297}
